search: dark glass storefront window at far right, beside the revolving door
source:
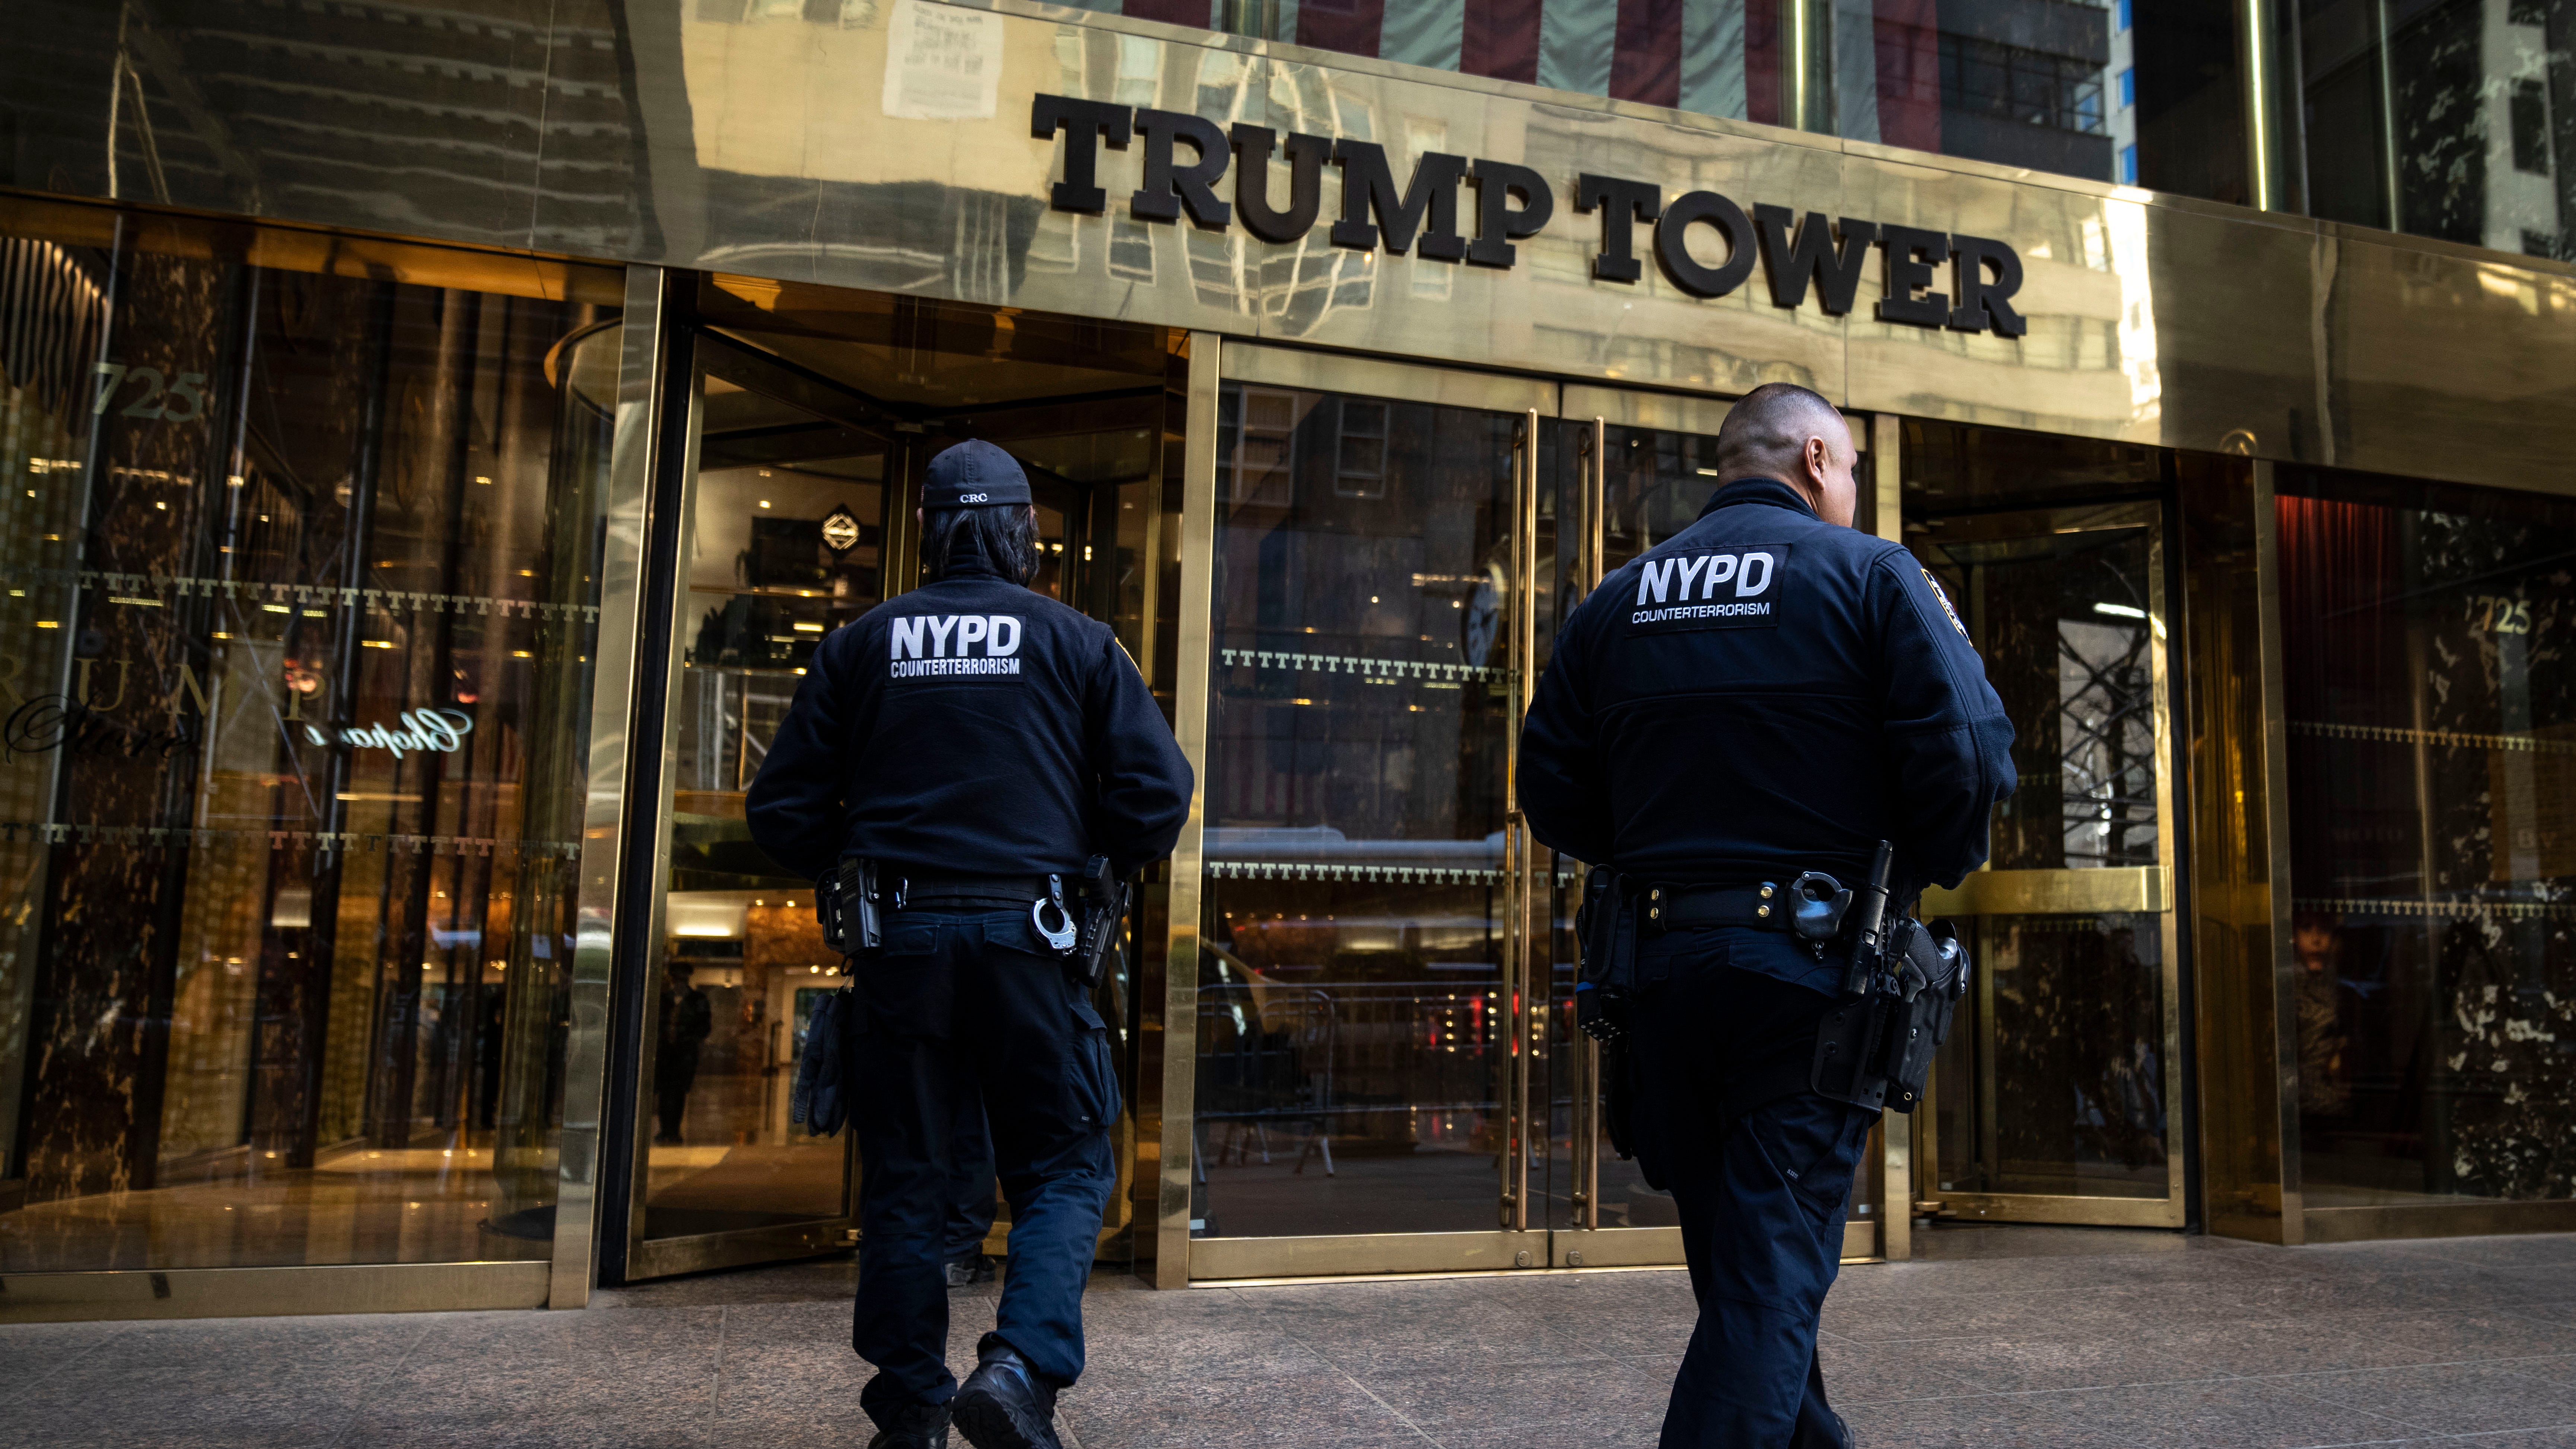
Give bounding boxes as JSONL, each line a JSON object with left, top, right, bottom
{"left": 2277, "top": 469, "right": 2576, "bottom": 1207}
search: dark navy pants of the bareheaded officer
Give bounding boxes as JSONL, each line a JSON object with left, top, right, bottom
{"left": 1636, "top": 928, "right": 1878, "bottom": 1449}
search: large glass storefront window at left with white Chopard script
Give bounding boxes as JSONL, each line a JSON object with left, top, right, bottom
{"left": 0, "top": 201, "right": 621, "bottom": 1271}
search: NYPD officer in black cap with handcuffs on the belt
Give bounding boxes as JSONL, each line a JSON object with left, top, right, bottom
{"left": 750, "top": 441, "right": 1190, "bottom": 1449}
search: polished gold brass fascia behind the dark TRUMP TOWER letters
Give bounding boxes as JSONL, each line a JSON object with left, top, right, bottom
{"left": 639, "top": 0, "right": 2576, "bottom": 487}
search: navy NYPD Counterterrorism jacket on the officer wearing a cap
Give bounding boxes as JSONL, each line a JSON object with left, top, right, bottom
{"left": 750, "top": 552, "right": 1193, "bottom": 890}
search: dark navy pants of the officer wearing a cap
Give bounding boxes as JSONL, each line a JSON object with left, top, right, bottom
{"left": 847, "top": 910, "right": 1118, "bottom": 1426}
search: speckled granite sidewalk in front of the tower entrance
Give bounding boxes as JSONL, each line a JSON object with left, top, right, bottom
{"left": 0, "top": 1227, "right": 2576, "bottom": 1449}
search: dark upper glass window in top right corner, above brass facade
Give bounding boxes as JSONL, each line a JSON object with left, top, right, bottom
{"left": 2298, "top": 0, "right": 2576, "bottom": 260}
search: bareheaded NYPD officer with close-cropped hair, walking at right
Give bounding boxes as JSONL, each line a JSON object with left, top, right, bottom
{"left": 1520, "top": 384, "right": 2014, "bottom": 1449}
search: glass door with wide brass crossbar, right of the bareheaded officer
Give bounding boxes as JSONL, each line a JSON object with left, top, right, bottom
{"left": 1909, "top": 503, "right": 2182, "bottom": 1227}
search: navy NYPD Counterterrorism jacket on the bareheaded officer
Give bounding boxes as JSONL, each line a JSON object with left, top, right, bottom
{"left": 1520, "top": 480, "right": 2014, "bottom": 985}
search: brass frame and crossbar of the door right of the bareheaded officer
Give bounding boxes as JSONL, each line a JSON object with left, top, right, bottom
{"left": 1927, "top": 500, "right": 2192, "bottom": 1227}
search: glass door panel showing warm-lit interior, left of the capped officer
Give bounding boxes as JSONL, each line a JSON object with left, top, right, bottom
{"left": 629, "top": 340, "right": 899, "bottom": 1263}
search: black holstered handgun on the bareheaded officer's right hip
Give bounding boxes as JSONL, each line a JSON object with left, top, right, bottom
{"left": 1808, "top": 841, "right": 1968, "bottom": 1111}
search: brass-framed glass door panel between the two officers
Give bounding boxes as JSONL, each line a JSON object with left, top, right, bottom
{"left": 1190, "top": 369, "right": 1543, "bottom": 1276}
